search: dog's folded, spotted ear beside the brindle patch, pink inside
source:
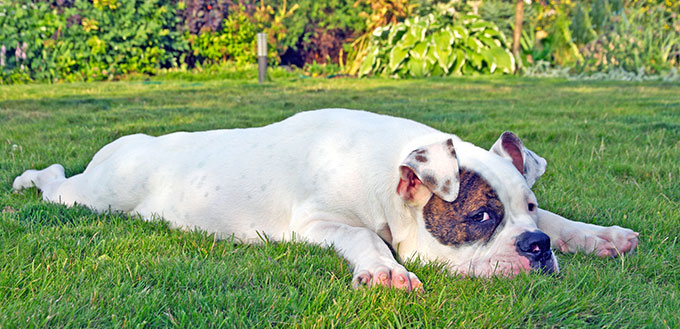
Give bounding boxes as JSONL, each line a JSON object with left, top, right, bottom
{"left": 397, "top": 138, "right": 460, "bottom": 205}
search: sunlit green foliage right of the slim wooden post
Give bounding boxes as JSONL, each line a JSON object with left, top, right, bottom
{"left": 523, "top": 0, "right": 680, "bottom": 76}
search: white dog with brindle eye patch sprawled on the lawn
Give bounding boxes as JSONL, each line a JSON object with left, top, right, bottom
{"left": 13, "top": 109, "right": 638, "bottom": 290}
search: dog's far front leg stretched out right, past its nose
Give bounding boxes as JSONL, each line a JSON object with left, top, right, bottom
{"left": 537, "top": 209, "right": 638, "bottom": 257}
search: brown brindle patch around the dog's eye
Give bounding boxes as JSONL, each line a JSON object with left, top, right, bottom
{"left": 423, "top": 169, "right": 504, "bottom": 245}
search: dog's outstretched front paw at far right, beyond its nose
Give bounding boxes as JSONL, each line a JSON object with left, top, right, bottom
{"left": 557, "top": 226, "right": 639, "bottom": 257}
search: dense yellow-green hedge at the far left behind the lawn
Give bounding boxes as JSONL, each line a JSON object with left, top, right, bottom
{"left": 0, "top": 0, "right": 187, "bottom": 82}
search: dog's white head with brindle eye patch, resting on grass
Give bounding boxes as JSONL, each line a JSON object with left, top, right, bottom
{"left": 397, "top": 132, "right": 558, "bottom": 276}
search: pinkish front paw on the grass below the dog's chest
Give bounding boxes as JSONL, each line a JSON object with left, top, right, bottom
{"left": 352, "top": 265, "right": 423, "bottom": 292}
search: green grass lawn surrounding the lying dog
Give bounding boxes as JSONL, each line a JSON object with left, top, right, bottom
{"left": 0, "top": 77, "right": 680, "bottom": 328}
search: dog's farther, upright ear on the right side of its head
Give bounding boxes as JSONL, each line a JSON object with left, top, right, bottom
{"left": 489, "top": 131, "right": 548, "bottom": 187}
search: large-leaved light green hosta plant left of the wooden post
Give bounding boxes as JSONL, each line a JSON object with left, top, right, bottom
{"left": 358, "top": 14, "right": 515, "bottom": 77}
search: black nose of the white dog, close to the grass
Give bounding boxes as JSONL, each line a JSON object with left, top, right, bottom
{"left": 516, "top": 231, "right": 555, "bottom": 274}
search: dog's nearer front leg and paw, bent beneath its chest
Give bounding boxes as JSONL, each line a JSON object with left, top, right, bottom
{"left": 296, "top": 221, "right": 422, "bottom": 291}
